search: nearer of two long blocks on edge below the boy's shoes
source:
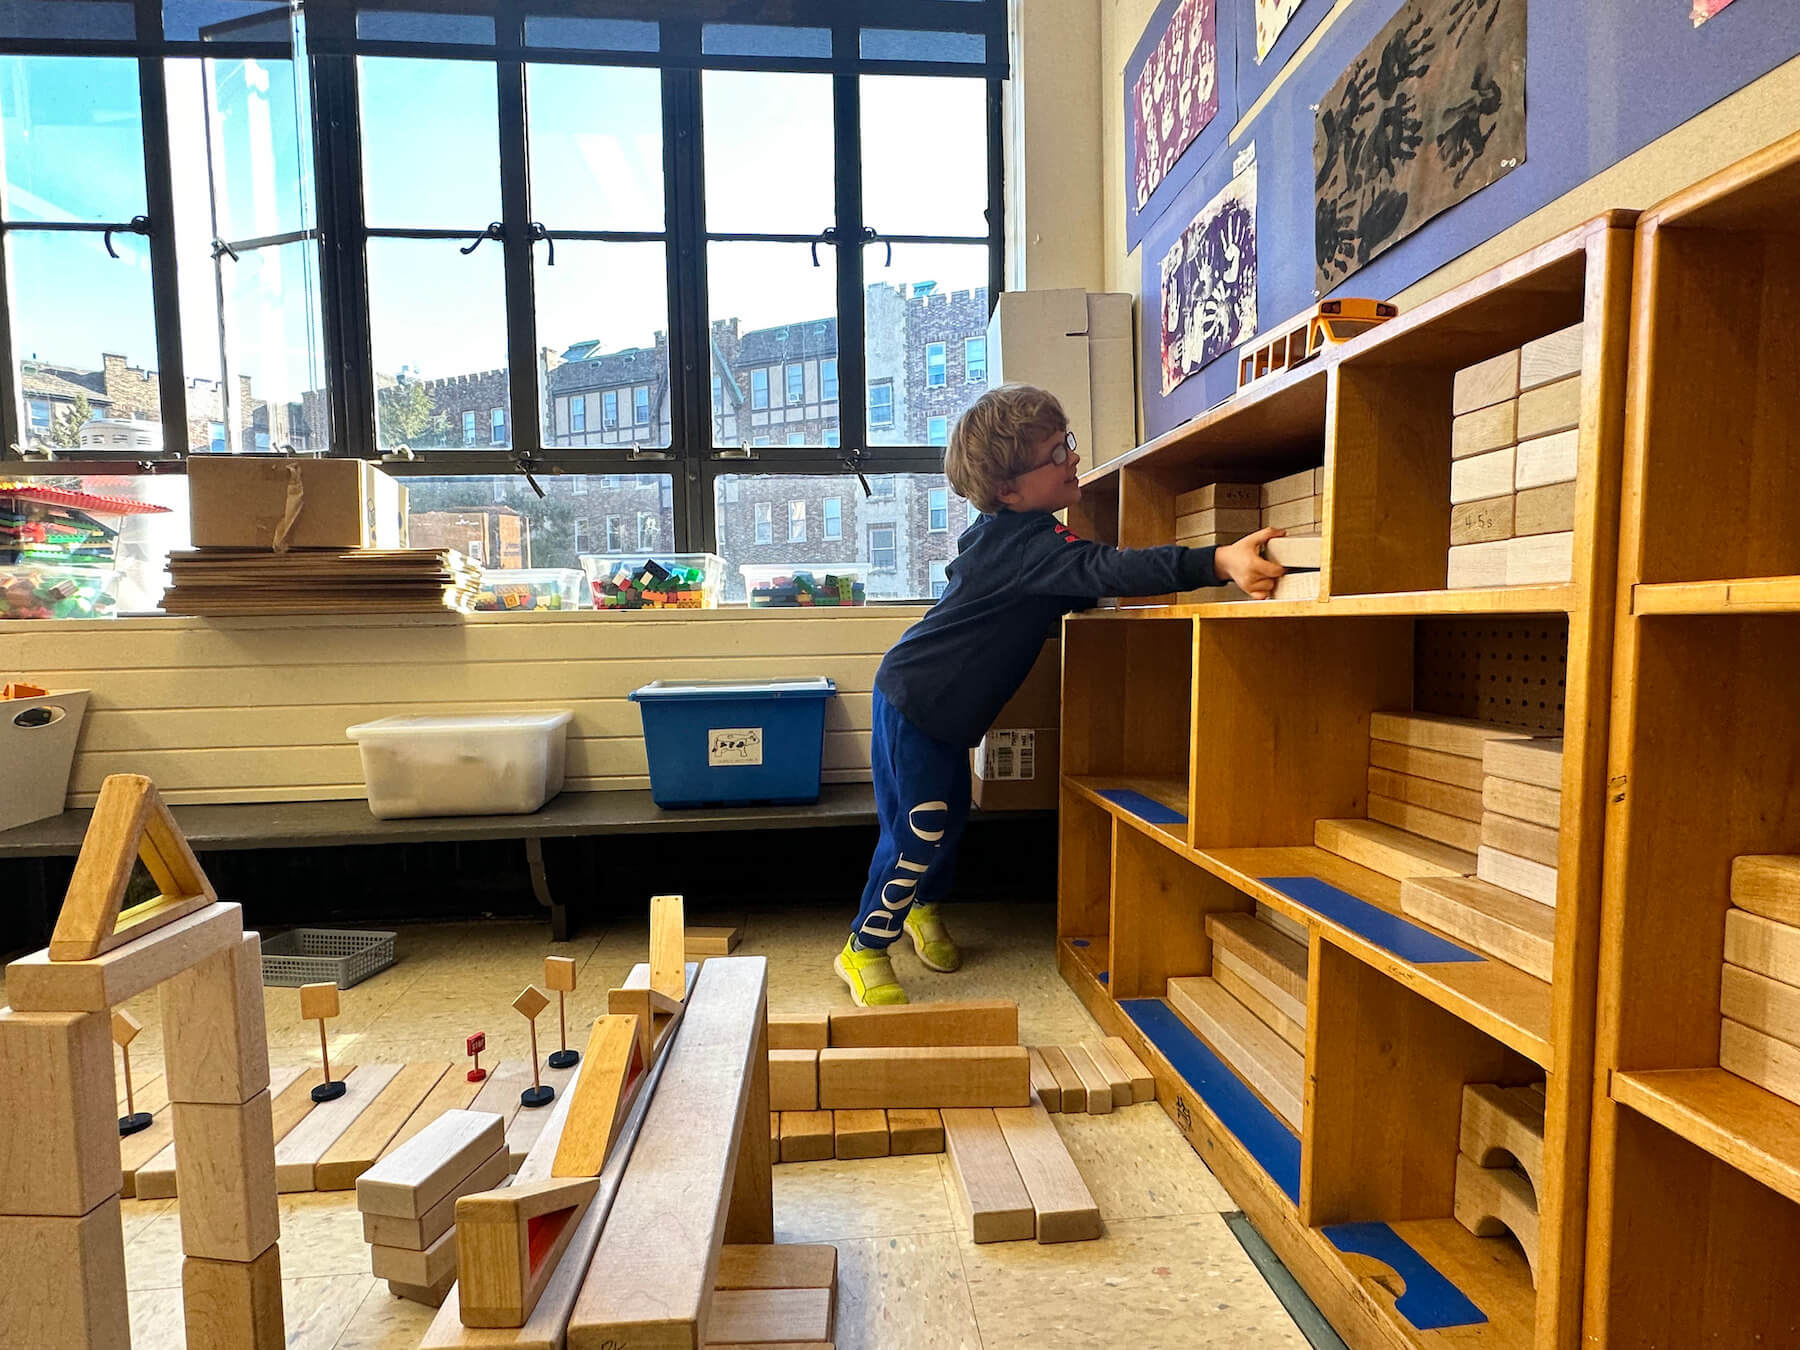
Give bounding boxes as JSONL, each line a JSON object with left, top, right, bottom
{"left": 819, "top": 1046, "right": 1029, "bottom": 1111}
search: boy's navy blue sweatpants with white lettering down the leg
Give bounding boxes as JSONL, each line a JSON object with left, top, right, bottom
{"left": 855, "top": 689, "right": 968, "bottom": 947}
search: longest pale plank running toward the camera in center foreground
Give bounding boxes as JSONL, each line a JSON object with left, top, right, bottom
{"left": 569, "top": 956, "right": 766, "bottom": 1350}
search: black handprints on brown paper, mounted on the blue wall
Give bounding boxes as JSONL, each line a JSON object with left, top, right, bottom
{"left": 1312, "top": 0, "right": 1525, "bottom": 295}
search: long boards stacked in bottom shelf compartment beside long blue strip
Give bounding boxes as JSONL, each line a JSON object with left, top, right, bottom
{"left": 1168, "top": 907, "right": 1309, "bottom": 1130}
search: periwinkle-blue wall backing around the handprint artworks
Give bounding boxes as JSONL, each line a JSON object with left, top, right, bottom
{"left": 1125, "top": 0, "right": 1800, "bottom": 439}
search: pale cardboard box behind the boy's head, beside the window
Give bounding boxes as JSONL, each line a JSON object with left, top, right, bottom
{"left": 988, "top": 290, "right": 1138, "bottom": 468}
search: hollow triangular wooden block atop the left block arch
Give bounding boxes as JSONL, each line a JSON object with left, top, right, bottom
{"left": 50, "top": 774, "right": 218, "bottom": 961}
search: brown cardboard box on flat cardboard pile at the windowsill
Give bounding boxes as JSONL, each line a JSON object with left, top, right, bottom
{"left": 187, "top": 455, "right": 407, "bottom": 549}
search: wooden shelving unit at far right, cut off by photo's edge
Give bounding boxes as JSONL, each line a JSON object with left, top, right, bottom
{"left": 1588, "top": 137, "right": 1800, "bottom": 1346}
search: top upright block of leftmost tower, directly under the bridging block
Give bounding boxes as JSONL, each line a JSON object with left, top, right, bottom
{"left": 0, "top": 1008, "right": 119, "bottom": 1219}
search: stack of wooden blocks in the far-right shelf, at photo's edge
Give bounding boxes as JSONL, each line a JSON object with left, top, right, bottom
{"left": 1719, "top": 855, "right": 1800, "bottom": 1103}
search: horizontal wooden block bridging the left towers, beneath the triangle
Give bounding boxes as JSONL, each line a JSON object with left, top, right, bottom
{"left": 5, "top": 900, "right": 243, "bottom": 1008}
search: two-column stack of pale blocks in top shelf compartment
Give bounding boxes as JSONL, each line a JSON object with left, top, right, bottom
{"left": 1447, "top": 324, "right": 1582, "bottom": 590}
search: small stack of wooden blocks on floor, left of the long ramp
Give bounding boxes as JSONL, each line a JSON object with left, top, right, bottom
{"left": 356, "top": 1111, "right": 513, "bottom": 1307}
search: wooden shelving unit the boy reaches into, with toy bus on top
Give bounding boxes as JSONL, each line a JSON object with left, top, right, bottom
{"left": 1058, "top": 212, "right": 1641, "bottom": 1350}
